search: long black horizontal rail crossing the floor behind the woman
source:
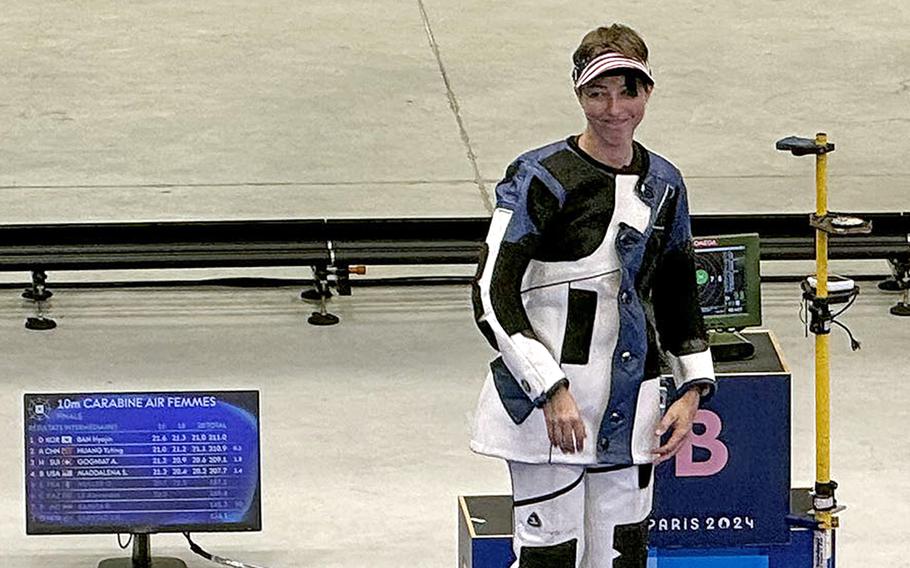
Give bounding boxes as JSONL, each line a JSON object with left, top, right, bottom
{"left": 0, "top": 212, "right": 910, "bottom": 271}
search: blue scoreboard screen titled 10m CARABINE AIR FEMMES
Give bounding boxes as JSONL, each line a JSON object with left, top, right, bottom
{"left": 25, "top": 391, "right": 261, "bottom": 534}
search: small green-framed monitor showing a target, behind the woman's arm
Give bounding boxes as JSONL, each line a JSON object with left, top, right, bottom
{"left": 693, "top": 233, "right": 761, "bottom": 330}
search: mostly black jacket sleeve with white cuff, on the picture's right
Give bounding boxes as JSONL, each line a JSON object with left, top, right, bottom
{"left": 653, "top": 178, "right": 715, "bottom": 400}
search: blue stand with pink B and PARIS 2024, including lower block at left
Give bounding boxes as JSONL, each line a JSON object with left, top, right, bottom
{"left": 458, "top": 331, "right": 832, "bottom": 568}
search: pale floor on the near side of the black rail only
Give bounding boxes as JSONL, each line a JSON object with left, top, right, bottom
{"left": 0, "top": 284, "right": 910, "bottom": 568}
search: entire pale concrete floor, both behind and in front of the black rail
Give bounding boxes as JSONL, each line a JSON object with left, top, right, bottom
{"left": 0, "top": 0, "right": 910, "bottom": 568}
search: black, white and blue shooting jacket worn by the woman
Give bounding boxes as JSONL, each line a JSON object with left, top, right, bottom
{"left": 471, "top": 138, "right": 714, "bottom": 465}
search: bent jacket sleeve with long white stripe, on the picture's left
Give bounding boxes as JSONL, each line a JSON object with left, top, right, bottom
{"left": 472, "top": 164, "right": 567, "bottom": 404}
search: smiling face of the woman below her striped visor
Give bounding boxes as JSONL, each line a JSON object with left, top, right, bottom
{"left": 578, "top": 75, "right": 651, "bottom": 145}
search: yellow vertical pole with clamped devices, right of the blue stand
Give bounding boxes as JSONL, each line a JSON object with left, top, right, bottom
{"left": 815, "top": 133, "right": 831, "bottom": 529}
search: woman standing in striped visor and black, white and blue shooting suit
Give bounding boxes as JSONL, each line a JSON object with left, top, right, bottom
{"left": 471, "top": 24, "right": 714, "bottom": 568}
